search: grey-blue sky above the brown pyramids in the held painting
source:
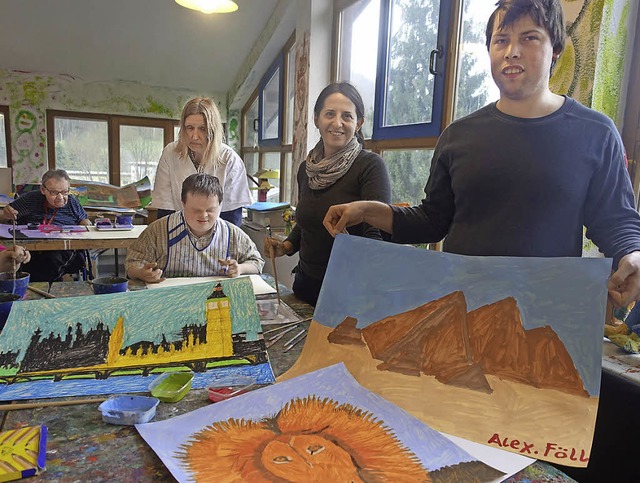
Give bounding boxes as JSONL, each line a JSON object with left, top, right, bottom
{"left": 314, "top": 235, "right": 611, "bottom": 395}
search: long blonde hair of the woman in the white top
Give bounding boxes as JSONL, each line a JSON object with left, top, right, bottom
{"left": 176, "top": 97, "right": 223, "bottom": 169}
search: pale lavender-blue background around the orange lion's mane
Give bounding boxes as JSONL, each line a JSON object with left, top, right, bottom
{"left": 136, "top": 364, "right": 474, "bottom": 481}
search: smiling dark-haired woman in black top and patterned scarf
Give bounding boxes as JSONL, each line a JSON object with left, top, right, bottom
{"left": 264, "top": 82, "right": 391, "bottom": 306}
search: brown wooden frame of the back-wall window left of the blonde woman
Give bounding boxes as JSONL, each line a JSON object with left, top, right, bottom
{"left": 46, "top": 109, "right": 180, "bottom": 186}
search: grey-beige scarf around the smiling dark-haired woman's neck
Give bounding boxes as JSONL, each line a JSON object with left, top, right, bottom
{"left": 305, "top": 136, "right": 362, "bottom": 190}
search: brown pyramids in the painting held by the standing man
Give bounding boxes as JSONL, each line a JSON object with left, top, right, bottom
{"left": 328, "top": 291, "right": 588, "bottom": 397}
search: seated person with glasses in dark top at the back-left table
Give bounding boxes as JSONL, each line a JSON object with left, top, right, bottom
{"left": 2, "top": 169, "right": 91, "bottom": 282}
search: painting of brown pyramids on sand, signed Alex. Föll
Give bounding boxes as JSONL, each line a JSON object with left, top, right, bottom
{"left": 280, "top": 235, "right": 611, "bottom": 466}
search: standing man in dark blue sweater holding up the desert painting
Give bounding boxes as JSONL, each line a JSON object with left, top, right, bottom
{"left": 324, "top": 0, "right": 640, "bottom": 305}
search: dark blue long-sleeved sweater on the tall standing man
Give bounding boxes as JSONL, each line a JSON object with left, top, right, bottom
{"left": 393, "top": 98, "right": 640, "bottom": 263}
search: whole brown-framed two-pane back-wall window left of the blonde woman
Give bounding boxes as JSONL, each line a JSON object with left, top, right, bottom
{"left": 47, "top": 111, "right": 179, "bottom": 186}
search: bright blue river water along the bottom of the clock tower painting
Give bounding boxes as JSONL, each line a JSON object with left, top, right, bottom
{"left": 0, "top": 363, "right": 275, "bottom": 401}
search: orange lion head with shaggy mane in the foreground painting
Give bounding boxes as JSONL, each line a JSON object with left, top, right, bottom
{"left": 177, "top": 396, "right": 431, "bottom": 483}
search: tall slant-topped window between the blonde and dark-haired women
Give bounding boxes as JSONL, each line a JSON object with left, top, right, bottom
{"left": 241, "top": 34, "right": 295, "bottom": 201}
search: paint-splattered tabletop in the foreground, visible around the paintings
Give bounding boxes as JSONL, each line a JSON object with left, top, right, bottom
{"left": 0, "top": 275, "right": 573, "bottom": 483}
